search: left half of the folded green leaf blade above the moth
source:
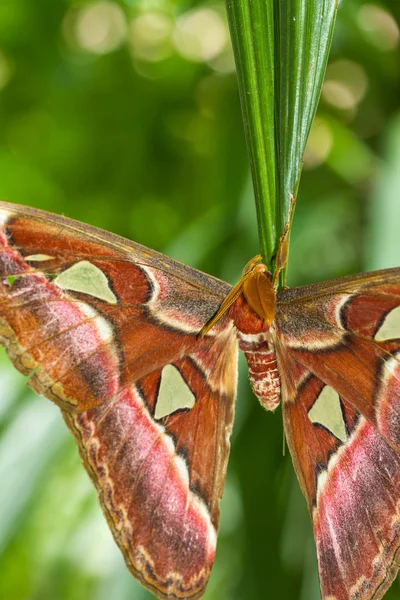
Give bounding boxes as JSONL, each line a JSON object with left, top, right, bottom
{"left": 227, "top": 0, "right": 277, "bottom": 263}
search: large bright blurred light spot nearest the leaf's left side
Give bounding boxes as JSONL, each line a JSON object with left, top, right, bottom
{"left": 173, "top": 8, "right": 228, "bottom": 62}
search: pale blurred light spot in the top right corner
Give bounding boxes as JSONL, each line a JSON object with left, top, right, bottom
{"left": 357, "top": 4, "right": 400, "bottom": 52}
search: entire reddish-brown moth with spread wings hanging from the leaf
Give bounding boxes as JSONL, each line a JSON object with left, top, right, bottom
{"left": 0, "top": 202, "right": 400, "bottom": 600}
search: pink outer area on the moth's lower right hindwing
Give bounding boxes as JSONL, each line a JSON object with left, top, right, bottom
{"left": 313, "top": 417, "right": 400, "bottom": 600}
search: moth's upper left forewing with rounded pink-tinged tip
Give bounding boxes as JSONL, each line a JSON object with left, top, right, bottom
{"left": 0, "top": 203, "right": 230, "bottom": 411}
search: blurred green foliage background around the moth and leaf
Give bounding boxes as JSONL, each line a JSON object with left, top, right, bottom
{"left": 0, "top": 0, "right": 400, "bottom": 600}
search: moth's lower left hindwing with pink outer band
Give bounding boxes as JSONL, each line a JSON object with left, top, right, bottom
{"left": 64, "top": 343, "right": 237, "bottom": 599}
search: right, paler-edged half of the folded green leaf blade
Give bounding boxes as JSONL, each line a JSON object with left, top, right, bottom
{"left": 275, "top": 0, "right": 338, "bottom": 226}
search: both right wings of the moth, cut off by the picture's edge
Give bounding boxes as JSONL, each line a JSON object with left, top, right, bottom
{"left": 276, "top": 269, "right": 400, "bottom": 600}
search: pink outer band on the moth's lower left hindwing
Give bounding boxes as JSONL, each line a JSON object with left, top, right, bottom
{"left": 64, "top": 386, "right": 216, "bottom": 597}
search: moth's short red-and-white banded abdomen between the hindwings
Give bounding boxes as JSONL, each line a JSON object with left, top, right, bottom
{"left": 239, "top": 334, "right": 281, "bottom": 410}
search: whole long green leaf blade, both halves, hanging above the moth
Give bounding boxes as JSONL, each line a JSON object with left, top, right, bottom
{"left": 227, "top": 0, "right": 337, "bottom": 274}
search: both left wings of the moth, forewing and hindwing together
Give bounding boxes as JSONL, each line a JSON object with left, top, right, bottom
{"left": 0, "top": 203, "right": 237, "bottom": 598}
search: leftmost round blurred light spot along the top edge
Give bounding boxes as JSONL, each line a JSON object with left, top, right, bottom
{"left": 75, "top": 2, "right": 127, "bottom": 54}
